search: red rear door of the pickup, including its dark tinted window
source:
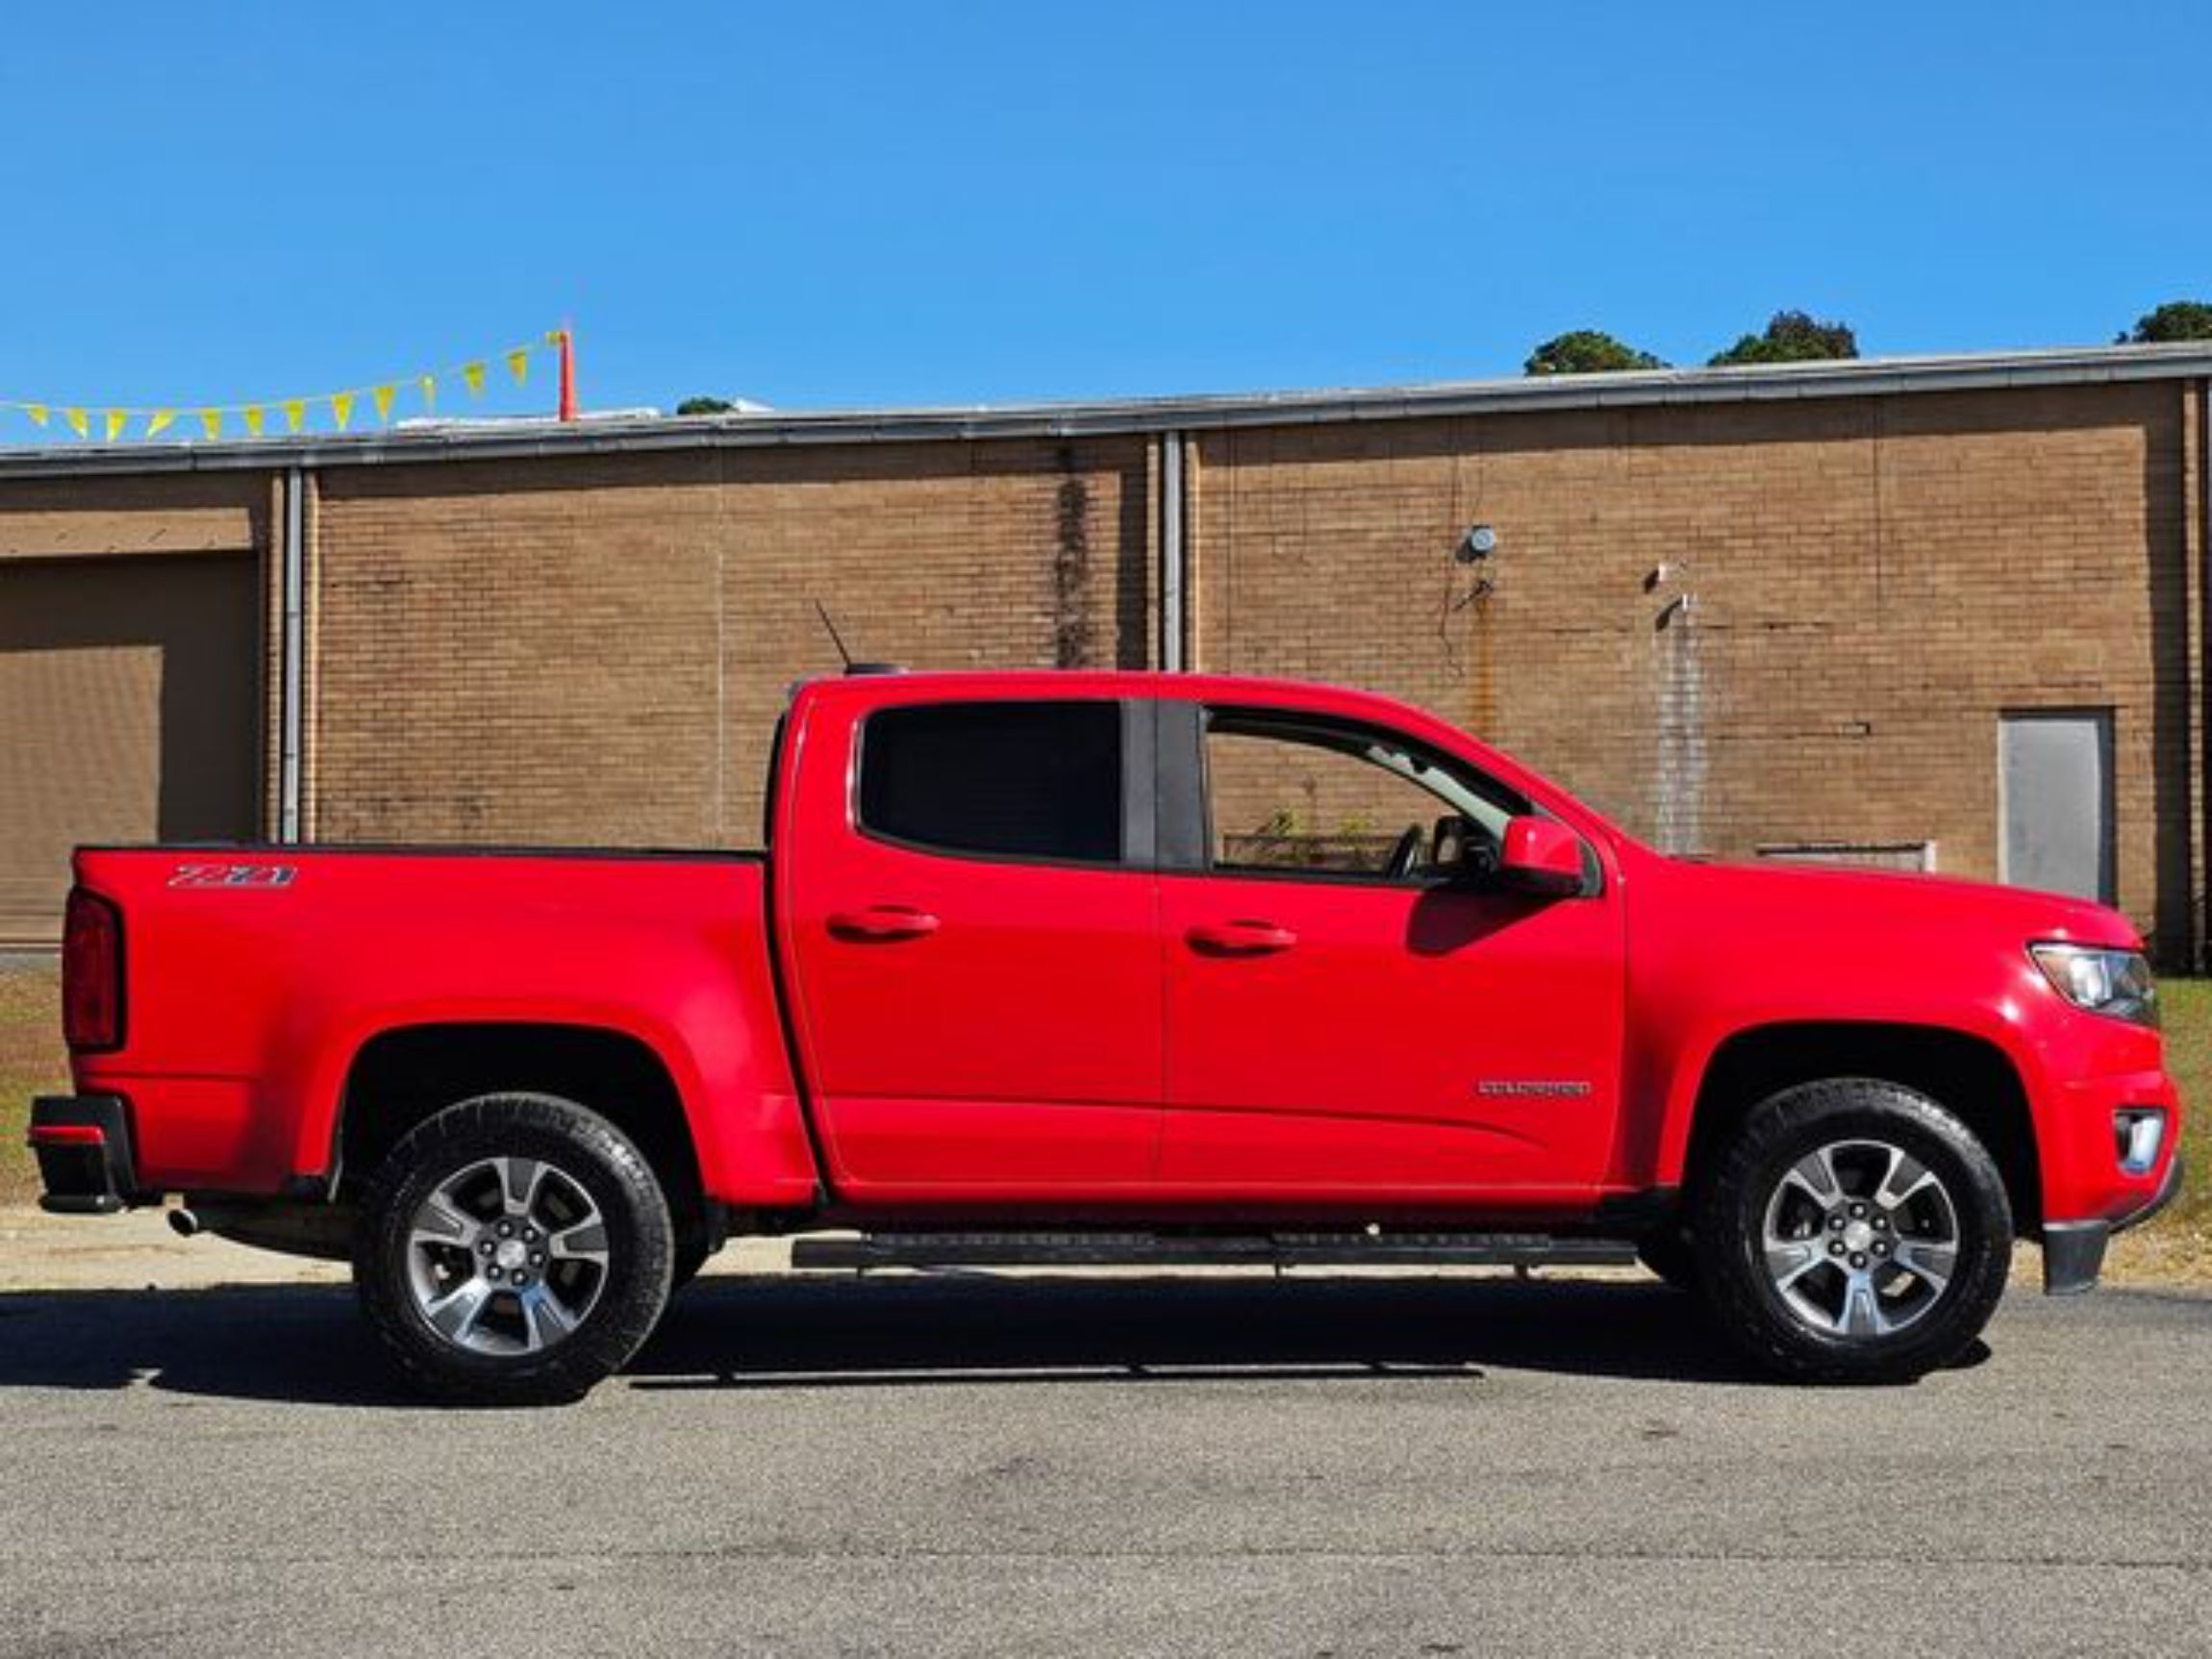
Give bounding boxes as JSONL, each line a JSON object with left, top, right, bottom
{"left": 776, "top": 691, "right": 1162, "bottom": 1203}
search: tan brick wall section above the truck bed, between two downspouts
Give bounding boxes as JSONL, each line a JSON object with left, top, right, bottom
{"left": 312, "top": 438, "right": 1157, "bottom": 845}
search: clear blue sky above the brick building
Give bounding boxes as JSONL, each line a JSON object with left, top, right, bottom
{"left": 0, "top": 0, "right": 2212, "bottom": 429}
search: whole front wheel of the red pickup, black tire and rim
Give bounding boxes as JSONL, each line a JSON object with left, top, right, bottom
{"left": 1690, "top": 1077, "right": 2013, "bottom": 1383}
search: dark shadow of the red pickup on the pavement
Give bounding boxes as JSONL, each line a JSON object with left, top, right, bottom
{"left": 0, "top": 1274, "right": 1920, "bottom": 1407}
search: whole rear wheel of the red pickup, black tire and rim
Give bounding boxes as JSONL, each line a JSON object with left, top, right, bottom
{"left": 354, "top": 1095, "right": 677, "bottom": 1405}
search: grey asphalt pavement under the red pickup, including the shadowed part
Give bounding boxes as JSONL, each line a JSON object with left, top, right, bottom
{"left": 0, "top": 1276, "right": 2212, "bottom": 1659}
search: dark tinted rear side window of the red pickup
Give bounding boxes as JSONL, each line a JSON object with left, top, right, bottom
{"left": 861, "top": 701, "right": 1121, "bottom": 865}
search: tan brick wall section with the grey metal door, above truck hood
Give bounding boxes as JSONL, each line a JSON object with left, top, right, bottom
{"left": 1190, "top": 385, "right": 2190, "bottom": 955}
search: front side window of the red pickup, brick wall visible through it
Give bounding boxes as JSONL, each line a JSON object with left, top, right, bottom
{"left": 1206, "top": 708, "right": 1528, "bottom": 883}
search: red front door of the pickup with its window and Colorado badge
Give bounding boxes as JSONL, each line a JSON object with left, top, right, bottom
{"left": 1162, "top": 706, "right": 1623, "bottom": 1206}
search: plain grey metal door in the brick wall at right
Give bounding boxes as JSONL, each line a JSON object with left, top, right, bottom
{"left": 1998, "top": 708, "right": 2115, "bottom": 905}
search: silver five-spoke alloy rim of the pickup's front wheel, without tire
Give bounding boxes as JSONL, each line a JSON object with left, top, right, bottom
{"left": 1761, "top": 1140, "right": 1960, "bottom": 1339}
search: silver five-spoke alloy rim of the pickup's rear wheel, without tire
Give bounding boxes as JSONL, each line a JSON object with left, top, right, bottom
{"left": 407, "top": 1157, "right": 609, "bottom": 1356}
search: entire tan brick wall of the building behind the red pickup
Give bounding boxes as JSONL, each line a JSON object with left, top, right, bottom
{"left": 0, "top": 381, "right": 2207, "bottom": 951}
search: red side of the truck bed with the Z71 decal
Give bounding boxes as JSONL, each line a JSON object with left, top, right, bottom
{"left": 75, "top": 845, "right": 814, "bottom": 1201}
